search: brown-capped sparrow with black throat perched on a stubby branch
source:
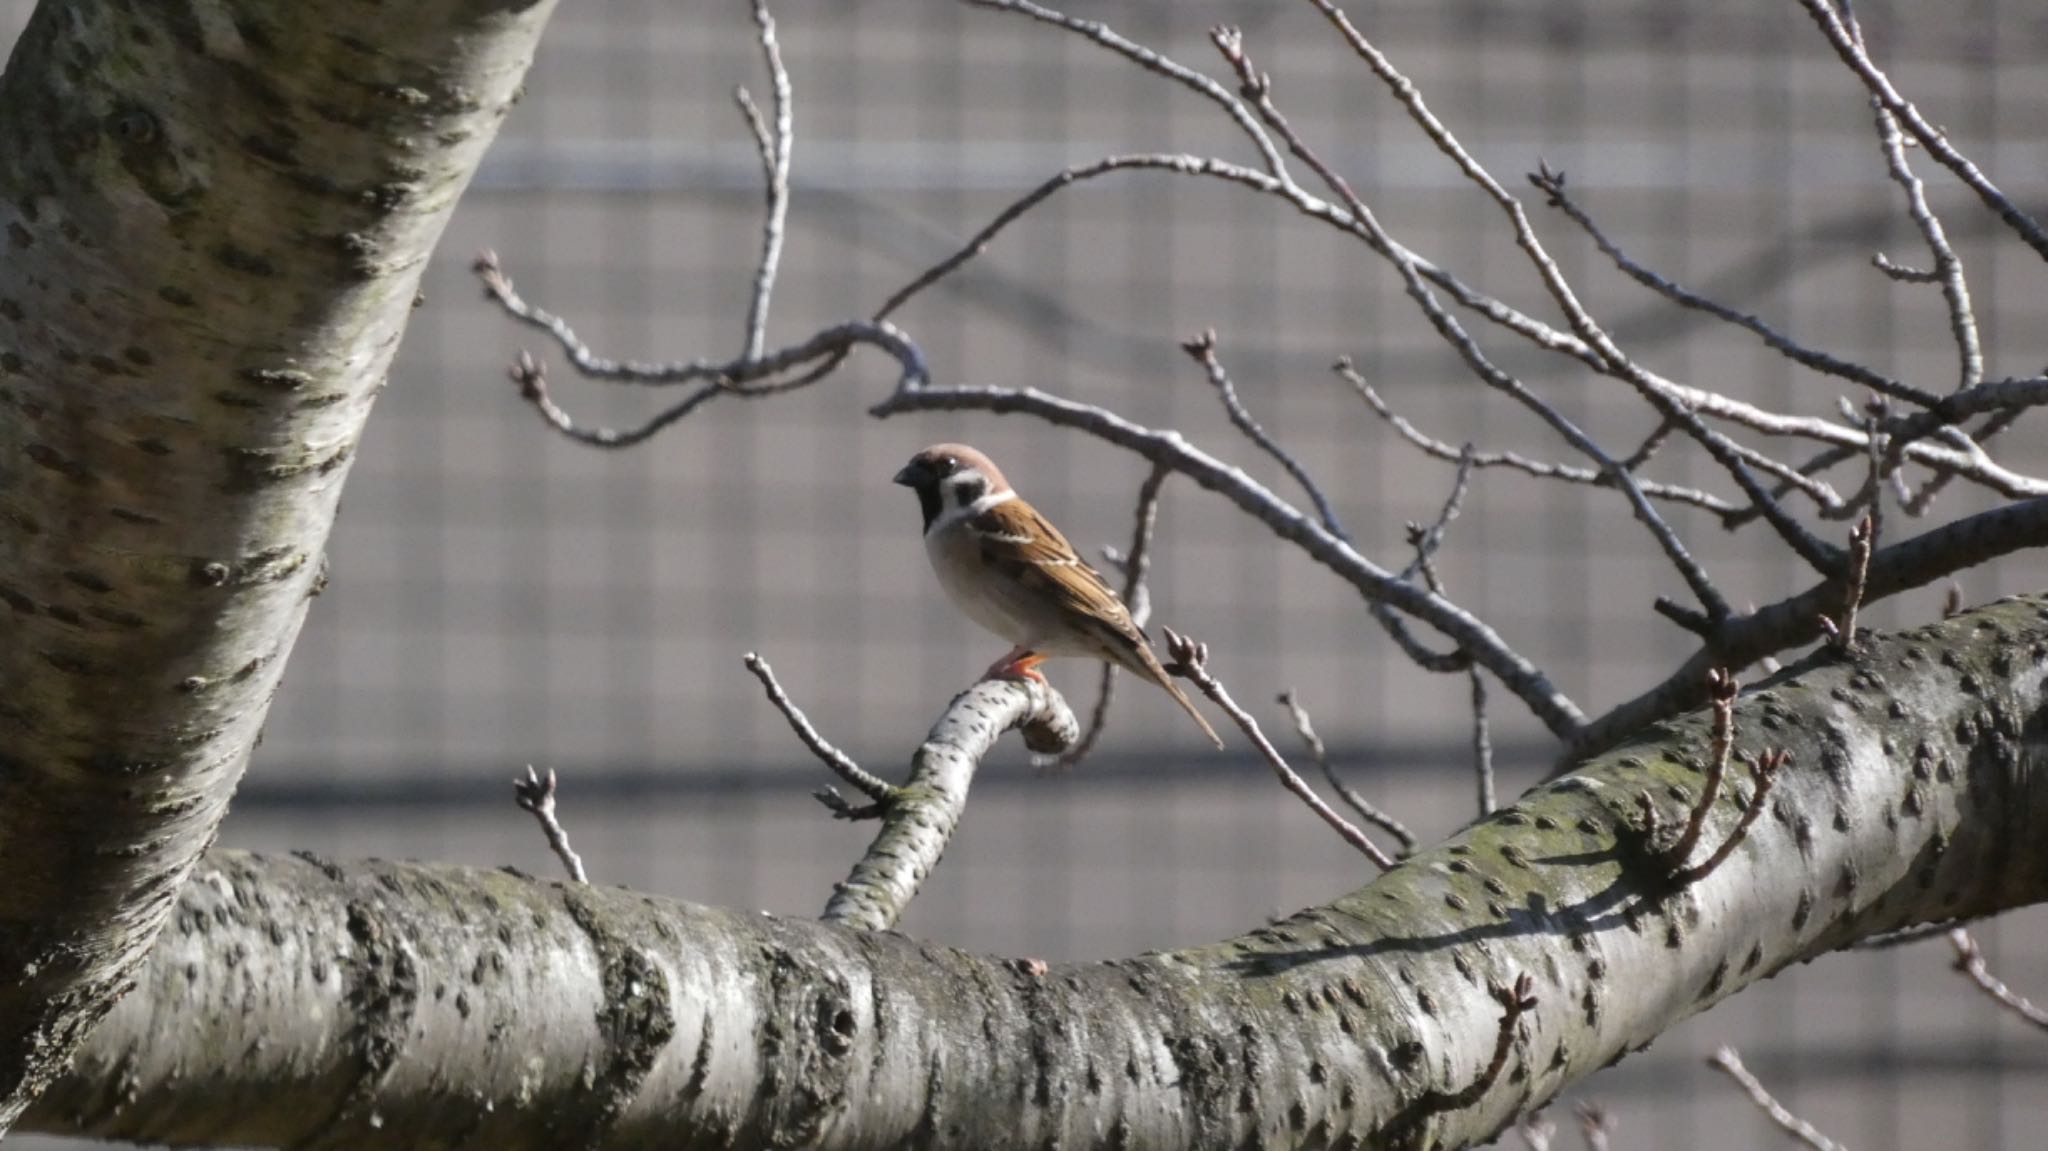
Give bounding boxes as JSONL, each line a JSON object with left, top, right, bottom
{"left": 895, "top": 444, "right": 1223, "bottom": 748}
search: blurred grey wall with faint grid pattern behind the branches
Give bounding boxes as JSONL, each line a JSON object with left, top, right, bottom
{"left": 0, "top": 0, "right": 2048, "bottom": 1149}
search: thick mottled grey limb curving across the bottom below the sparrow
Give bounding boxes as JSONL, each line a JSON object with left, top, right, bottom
{"left": 27, "top": 596, "right": 2048, "bottom": 1151}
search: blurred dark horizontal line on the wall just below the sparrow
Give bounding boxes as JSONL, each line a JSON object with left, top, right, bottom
{"left": 236, "top": 743, "right": 1556, "bottom": 813}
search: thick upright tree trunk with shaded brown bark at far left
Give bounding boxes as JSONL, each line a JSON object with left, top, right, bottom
{"left": 0, "top": 0, "right": 553, "bottom": 1133}
